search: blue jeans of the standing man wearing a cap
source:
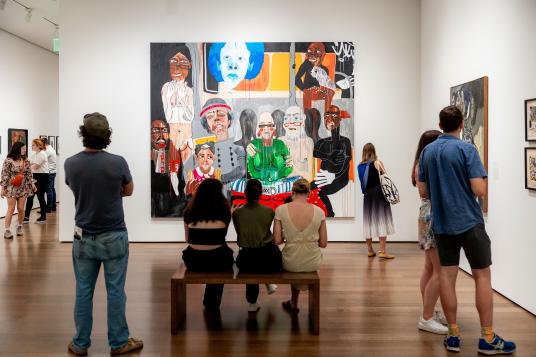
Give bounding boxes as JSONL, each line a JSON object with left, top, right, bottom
{"left": 73, "top": 230, "right": 129, "bottom": 348}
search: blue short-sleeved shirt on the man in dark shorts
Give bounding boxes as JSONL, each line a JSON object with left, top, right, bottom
{"left": 419, "top": 134, "right": 488, "bottom": 235}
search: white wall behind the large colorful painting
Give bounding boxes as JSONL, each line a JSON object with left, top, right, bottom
{"left": 60, "top": 0, "right": 420, "bottom": 241}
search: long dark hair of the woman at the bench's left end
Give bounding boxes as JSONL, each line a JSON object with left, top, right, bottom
{"left": 184, "top": 179, "right": 231, "bottom": 225}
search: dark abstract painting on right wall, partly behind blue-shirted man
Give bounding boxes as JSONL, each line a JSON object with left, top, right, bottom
{"left": 450, "top": 77, "right": 488, "bottom": 212}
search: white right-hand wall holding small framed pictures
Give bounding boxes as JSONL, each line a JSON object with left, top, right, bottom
{"left": 421, "top": 0, "right": 536, "bottom": 313}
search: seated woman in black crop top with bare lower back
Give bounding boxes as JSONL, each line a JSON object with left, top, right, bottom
{"left": 182, "top": 179, "right": 234, "bottom": 311}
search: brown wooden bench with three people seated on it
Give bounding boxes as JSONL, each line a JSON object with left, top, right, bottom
{"left": 171, "top": 264, "right": 320, "bottom": 335}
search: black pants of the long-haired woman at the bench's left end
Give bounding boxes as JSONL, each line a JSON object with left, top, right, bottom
{"left": 182, "top": 244, "right": 234, "bottom": 311}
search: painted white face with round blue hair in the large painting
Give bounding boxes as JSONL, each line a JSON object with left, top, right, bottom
{"left": 208, "top": 42, "right": 264, "bottom": 90}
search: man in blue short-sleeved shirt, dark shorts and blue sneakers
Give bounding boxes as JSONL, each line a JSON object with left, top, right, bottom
{"left": 418, "top": 105, "right": 516, "bottom": 355}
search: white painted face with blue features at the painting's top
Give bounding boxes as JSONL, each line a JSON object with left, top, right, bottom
{"left": 220, "top": 42, "right": 252, "bottom": 89}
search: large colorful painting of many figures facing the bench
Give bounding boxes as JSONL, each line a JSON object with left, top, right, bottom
{"left": 150, "top": 42, "right": 356, "bottom": 217}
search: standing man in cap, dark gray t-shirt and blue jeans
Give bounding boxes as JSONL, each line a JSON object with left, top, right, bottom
{"left": 65, "top": 113, "right": 143, "bottom": 356}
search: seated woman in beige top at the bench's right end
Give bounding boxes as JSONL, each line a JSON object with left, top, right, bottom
{"left": 273, "top": 179, "right": 328, "bottom": 313}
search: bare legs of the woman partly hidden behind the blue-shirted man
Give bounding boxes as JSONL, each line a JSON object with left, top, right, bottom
{"left": 421, "top": 248, "right": 441, "bottom": 320}
